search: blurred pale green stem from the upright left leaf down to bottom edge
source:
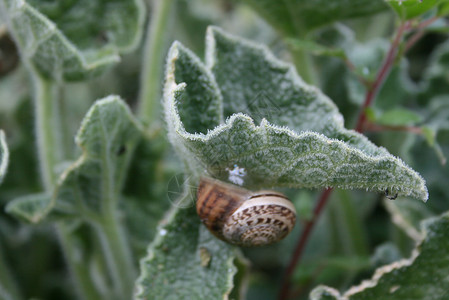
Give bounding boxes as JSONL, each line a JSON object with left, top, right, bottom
{"left": 93, "top": 208, "right": 136, "bottom": 299}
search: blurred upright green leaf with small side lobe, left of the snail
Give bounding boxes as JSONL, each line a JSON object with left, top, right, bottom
{"left": 8, "top": 96, "right": 142, "bottom": 222}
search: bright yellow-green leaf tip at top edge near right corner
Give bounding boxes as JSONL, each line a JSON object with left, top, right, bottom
{"left": 386, "top": 0, "right": 447, "bottom": 20}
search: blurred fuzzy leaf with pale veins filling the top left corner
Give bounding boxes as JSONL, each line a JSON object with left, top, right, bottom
{"left": 0, "top": 0, "right": 144, "bottom": 80}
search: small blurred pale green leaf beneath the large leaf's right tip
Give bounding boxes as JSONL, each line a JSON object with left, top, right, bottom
{"left": 384, "top": 198, "right": 434, "bottom": 241}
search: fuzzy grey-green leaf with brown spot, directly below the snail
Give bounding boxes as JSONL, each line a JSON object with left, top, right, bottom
{"left": 135, "top": 196, "right": 248, "bottom": 300}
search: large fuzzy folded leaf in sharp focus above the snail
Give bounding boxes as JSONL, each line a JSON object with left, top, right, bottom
{"left": 164, "top": 28, "right": 427, "bottom": 200}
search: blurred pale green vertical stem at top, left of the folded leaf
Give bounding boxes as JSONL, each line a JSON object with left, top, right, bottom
{"left": 138, "top": 0, "right": 173, "bottom": 123}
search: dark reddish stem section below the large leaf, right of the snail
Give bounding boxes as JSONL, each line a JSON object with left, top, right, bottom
{"left": 279, "top": 188, "right": 333, "bottom": 300}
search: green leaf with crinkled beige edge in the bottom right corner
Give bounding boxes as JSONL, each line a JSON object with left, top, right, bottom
{"left": 311, "top": 213, "right": 449, "bottom": 300}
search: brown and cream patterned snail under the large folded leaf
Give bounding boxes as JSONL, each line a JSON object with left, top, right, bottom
{"left": 196, "top": 177, "right": 296, "bottom": 247}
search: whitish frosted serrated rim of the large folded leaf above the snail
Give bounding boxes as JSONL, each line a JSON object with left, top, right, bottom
{"left": 164, "top": 26, "right": 428, "bottom": 202}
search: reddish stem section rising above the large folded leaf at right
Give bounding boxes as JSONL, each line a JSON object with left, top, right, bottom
{"left": 355, "top": 22, "right": 410, "bottom": 132}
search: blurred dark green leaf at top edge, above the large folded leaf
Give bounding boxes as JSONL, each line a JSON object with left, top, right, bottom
{"left": 240, "top": 0, "right": 387, "bottom": 38}
